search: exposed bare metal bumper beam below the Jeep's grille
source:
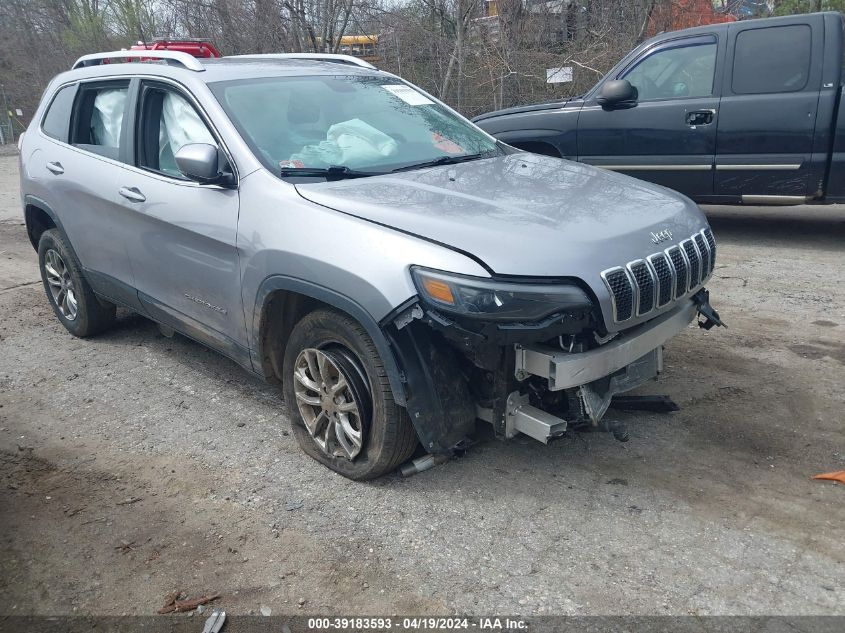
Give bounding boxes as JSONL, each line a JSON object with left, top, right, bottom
{"left": 516, "top": 300, "right": 698, "bottom": 391}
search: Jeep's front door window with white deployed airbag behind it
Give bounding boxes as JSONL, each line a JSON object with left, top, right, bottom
{"left": 138, "top": 85, "right": 217, "bottom": 178}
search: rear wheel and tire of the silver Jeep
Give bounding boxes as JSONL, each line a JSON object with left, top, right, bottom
{"left": 38, "top": 229, "right": 116, "bottom": 338}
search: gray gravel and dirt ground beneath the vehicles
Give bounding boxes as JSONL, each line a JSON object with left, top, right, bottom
{"left": 0, "top": 151, "right": 845, "bottom": 615}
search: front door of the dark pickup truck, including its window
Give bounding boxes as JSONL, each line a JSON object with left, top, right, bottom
{"left": 578, "top": 35, "right": 719, "bottom": 197}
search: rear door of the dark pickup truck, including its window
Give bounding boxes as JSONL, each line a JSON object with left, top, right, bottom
{"left": 716, "top": 16, "right": 826, "bottom": 203}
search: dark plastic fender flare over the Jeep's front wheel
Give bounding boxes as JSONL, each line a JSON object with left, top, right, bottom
{"left": 251, "top": 275, "right": 407, "bottom": 407}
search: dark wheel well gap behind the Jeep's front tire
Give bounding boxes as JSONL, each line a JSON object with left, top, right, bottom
{"left": 259, "top": 290, "right": 326, "bottom": 382}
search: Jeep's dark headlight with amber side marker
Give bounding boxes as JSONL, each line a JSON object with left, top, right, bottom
{"left": 411, "top": 267, "right": 591, "bottom": 321}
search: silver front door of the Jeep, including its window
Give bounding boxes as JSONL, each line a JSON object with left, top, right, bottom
{"left": 113, "top": 81, "right": 248, "bottom": 361}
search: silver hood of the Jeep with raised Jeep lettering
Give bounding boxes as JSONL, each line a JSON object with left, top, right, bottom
{"left": 297, "top": 152, "right": 707, "bottom": 280}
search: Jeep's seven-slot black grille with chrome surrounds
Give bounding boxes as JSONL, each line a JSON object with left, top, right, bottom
{"left": 601, "top": 229, "right": 716, "bottom": 323}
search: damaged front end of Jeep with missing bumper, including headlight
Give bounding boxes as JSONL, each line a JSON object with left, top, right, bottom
{"left": 385, "top": 269, "right": 722, "bottom": 453}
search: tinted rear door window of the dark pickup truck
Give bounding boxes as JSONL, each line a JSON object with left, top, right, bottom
{"left": 731, "top": 24, "right": 812, "bottom": 94}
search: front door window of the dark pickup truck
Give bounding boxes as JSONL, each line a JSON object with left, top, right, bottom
{"left": 622, "top": 41, "right": 716, "bottom": 101}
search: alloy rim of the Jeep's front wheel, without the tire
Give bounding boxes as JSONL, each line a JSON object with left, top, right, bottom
{"left": 293, "top": 348, "right": 369, "bottom": 461}
